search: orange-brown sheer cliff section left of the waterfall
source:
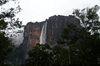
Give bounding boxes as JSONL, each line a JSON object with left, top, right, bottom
{"left": 22, "top": 22, "right": 44, "bottom": 51}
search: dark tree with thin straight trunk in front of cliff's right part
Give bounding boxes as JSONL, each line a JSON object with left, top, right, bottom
{"left": 57, "top": 24, "right": 79, "bottom": 64}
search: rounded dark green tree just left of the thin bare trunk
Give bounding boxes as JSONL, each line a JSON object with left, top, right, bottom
{"left": 52, "top": 45, "right": 68, "bottom": 66}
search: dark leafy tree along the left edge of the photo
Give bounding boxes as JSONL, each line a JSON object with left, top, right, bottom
{"left": 0, "top": 0, "right": 21, "bottom": 66}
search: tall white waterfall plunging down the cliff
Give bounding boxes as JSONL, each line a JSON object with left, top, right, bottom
{"left": 40, "top": 22, "right": 47, "bottom": 44}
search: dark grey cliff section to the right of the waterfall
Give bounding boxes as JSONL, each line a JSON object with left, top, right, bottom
{"left": 46, "top": 15, "right": 77, "bottom": 44}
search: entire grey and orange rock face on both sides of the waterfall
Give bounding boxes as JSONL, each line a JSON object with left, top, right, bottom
{"left": 8, "top": 15, "right": 78, "bottom": 64}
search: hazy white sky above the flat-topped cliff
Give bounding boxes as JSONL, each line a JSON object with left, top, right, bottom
{"left": 5, "top": 0, "right": 100, "bottom": 24}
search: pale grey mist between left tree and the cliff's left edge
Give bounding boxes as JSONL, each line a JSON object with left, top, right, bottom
{"left": 8, "top": 28, "right": 24, "bottom": 47}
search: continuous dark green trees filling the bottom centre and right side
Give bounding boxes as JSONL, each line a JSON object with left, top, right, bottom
{"left": 26, "top": 5, "right": 100, "bottom": 66}
